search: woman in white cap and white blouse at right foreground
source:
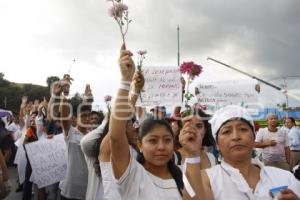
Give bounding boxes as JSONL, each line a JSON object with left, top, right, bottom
{"left": 193, "top": 105, "right": 300, "bottom": 200}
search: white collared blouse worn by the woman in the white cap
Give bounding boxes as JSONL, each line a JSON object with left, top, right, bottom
{"left": 206, "top": 161, "right": 300, "bottom": 200}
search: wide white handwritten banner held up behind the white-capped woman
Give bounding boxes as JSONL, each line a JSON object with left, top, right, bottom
{"left": 196, "top": 80, "right": 258, "bottom": 110}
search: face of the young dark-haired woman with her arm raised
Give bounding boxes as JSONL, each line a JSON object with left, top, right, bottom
{"left": 141, "top": 125, "right": 174, "bottom": 166}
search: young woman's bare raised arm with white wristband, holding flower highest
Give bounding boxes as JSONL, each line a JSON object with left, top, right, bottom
{"left": 109, "top": 44, "right": 135, "bottom": 179}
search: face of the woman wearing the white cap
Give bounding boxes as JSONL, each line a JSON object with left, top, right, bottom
{"left": 217, "top": 120, "right": 254, "bottom": 160}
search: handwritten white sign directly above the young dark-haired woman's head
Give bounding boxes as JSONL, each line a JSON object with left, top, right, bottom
{"left": 138, "top": 67, "right": 182, "bottom": 106}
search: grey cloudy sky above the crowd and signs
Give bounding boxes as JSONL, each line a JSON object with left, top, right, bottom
{"left": 0, "top": 0, "right": 300, "bottom": 109}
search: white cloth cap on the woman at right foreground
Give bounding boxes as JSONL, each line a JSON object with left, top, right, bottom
{"left": 209, "top": 105, "right": 254, "bottom": 140}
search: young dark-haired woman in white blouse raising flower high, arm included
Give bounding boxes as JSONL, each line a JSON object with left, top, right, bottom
{"left": 109, "top": 45, "right": 202, "bottom": 200}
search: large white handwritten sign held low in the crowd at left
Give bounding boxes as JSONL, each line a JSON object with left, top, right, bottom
{"left": 25, "top": 134, "right": 67, "bottom": 188}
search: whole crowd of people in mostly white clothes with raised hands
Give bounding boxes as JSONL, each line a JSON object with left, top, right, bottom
{"left": 0, "top": 45, "right": 300, "bottom": 200}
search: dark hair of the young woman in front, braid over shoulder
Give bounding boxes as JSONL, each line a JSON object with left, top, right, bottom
{"left": 137, "top": 118, "right": 184, "bottom": 196}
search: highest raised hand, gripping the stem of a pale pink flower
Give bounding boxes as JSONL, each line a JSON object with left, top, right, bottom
{"left": 119, "top": 44, "right": 135, "bottom": 82}
